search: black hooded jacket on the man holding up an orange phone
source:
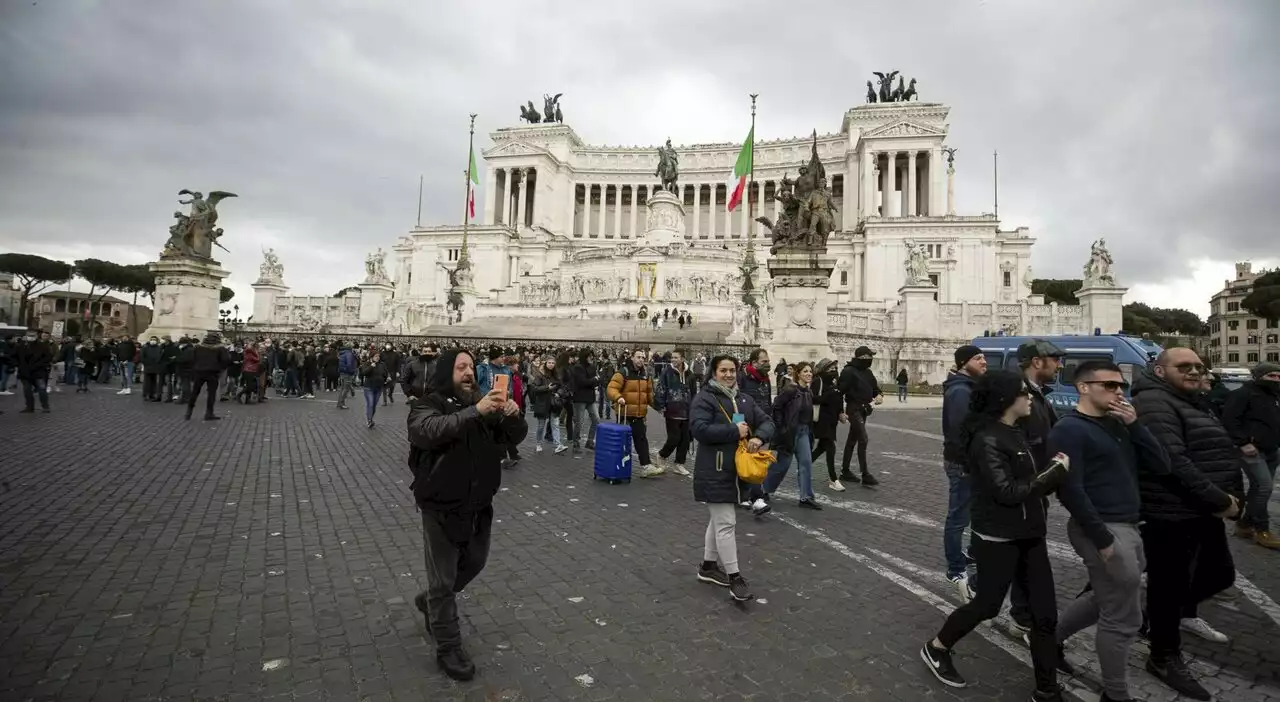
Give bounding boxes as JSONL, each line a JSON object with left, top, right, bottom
{"left": 408, "top": 350, "right": 529, "bottom": 520}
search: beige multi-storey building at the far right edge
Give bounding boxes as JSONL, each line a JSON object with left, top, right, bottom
{"left": 1208, "top": 261, "right": 1280, "bottom": 368}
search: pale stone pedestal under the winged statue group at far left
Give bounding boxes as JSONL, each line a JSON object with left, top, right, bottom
{"left": 141, "top": 259, "right": 229, "bottom": 341}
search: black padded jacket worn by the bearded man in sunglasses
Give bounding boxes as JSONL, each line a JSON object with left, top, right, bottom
{"left": 1133, "top": 369, "right": 1244, "bottom": 521}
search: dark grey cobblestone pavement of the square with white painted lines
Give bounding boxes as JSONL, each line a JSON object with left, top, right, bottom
{"left": 0, "top": 391, "right": 1280, "bottom": 701}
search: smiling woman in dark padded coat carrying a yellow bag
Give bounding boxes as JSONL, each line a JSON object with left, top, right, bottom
{"left": 689, "top": 356, "right": 773, "bottom": 602}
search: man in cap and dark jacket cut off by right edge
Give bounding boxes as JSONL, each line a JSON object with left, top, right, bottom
{"left": 1222, "top": 363, "right": 1280, "bottom": 548}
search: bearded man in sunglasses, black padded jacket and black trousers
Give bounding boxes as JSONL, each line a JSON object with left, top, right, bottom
{"left": 1133, "top": 347, "right": 1244, "bottom": 699}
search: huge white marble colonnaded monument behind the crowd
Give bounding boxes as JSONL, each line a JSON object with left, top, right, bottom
{"left": 247, "top": 96, "right": 1125, "bottom": 378}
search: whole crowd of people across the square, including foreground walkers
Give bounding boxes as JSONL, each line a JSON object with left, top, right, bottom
{"left": 0, "top": 334, "right": 1280, "bottom": 702}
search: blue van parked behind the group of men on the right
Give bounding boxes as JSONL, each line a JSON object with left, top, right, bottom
{"left": 973, "top": 334, "right": 1164, "bottom": 410}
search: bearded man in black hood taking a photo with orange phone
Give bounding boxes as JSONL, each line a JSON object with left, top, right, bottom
{"left": 408, "top": 350, "right": 529, "bottom": 680}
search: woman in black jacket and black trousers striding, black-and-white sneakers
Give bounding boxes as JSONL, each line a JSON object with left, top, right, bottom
{"left": 920, "top": 370, "right": 1068, "bottom": 699}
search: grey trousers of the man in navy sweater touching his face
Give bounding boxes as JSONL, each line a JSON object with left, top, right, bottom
{"left": 1057, "top": 519, "right": 1147, "bottom": 699}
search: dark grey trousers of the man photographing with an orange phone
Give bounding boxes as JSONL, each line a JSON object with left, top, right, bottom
{"left": 422, "top": 506, "right": 493, "bottom": 653}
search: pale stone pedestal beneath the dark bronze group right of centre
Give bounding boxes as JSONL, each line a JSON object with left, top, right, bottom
{"left": 768, "top": 249, "right": 836, "bottom": 363}
